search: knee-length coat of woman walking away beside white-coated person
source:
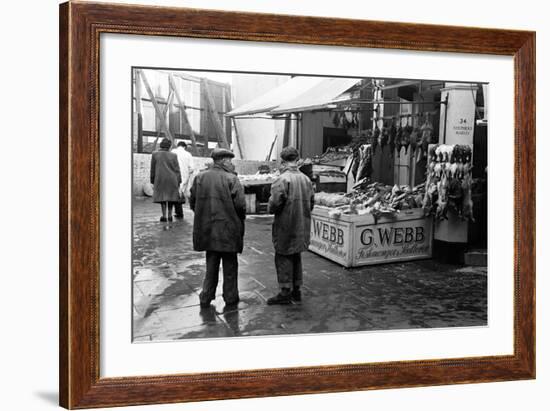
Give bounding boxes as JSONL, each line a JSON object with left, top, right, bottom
{"left": 150, "top": 150, "right": 181, "bottom": 203}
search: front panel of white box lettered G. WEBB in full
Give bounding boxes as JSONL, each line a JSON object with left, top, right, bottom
{"left": 353, "top": 218, "right": 432, "bottom": 265}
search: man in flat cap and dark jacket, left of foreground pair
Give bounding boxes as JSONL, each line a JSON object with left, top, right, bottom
{"left": 189, "top": 148, "right": 246, "bottom": 308}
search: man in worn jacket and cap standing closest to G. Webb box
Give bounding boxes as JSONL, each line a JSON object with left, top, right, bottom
{"left": 267, "top": 147, "right": 314, "bottom": 305}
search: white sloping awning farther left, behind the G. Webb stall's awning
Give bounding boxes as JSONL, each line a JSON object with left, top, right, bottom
{"left": 226, "top": 76, "right": 324, "bottom": 117}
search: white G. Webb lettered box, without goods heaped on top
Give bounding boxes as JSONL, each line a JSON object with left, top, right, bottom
{"left": 309, "top": 206, "right": 433, "bottom": 267}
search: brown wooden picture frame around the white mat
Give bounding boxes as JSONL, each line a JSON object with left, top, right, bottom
{"left": 59, "top": 2, "right": 535, "bottom": 409}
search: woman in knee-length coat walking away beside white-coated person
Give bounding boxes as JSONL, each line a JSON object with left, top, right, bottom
{"left": 151, "top": 138, "right": 181, "bottom": 222}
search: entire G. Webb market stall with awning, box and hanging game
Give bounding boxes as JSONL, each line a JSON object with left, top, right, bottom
{"left": 226, "top": 78, "right": 486, "bottom": 267}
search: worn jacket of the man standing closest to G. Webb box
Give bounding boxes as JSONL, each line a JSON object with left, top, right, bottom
{"left": 269, "top": 166, "right": 314, "bottom": 255}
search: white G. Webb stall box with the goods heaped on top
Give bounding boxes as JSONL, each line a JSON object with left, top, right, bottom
{"left": 309, "top": 183, "right": 433, "bottom": 267}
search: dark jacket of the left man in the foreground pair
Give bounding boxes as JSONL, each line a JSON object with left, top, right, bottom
{"left": 189, "top": 164, "right": 246, "bottom": 253}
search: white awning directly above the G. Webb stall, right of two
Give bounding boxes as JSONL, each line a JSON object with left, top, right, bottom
{"left": 269, "top": 78, "right": 361, "bottom": 115}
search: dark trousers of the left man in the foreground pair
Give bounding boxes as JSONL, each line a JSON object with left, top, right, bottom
{"left": 199, "top": 251, "right": 239, "bottom": 304}
